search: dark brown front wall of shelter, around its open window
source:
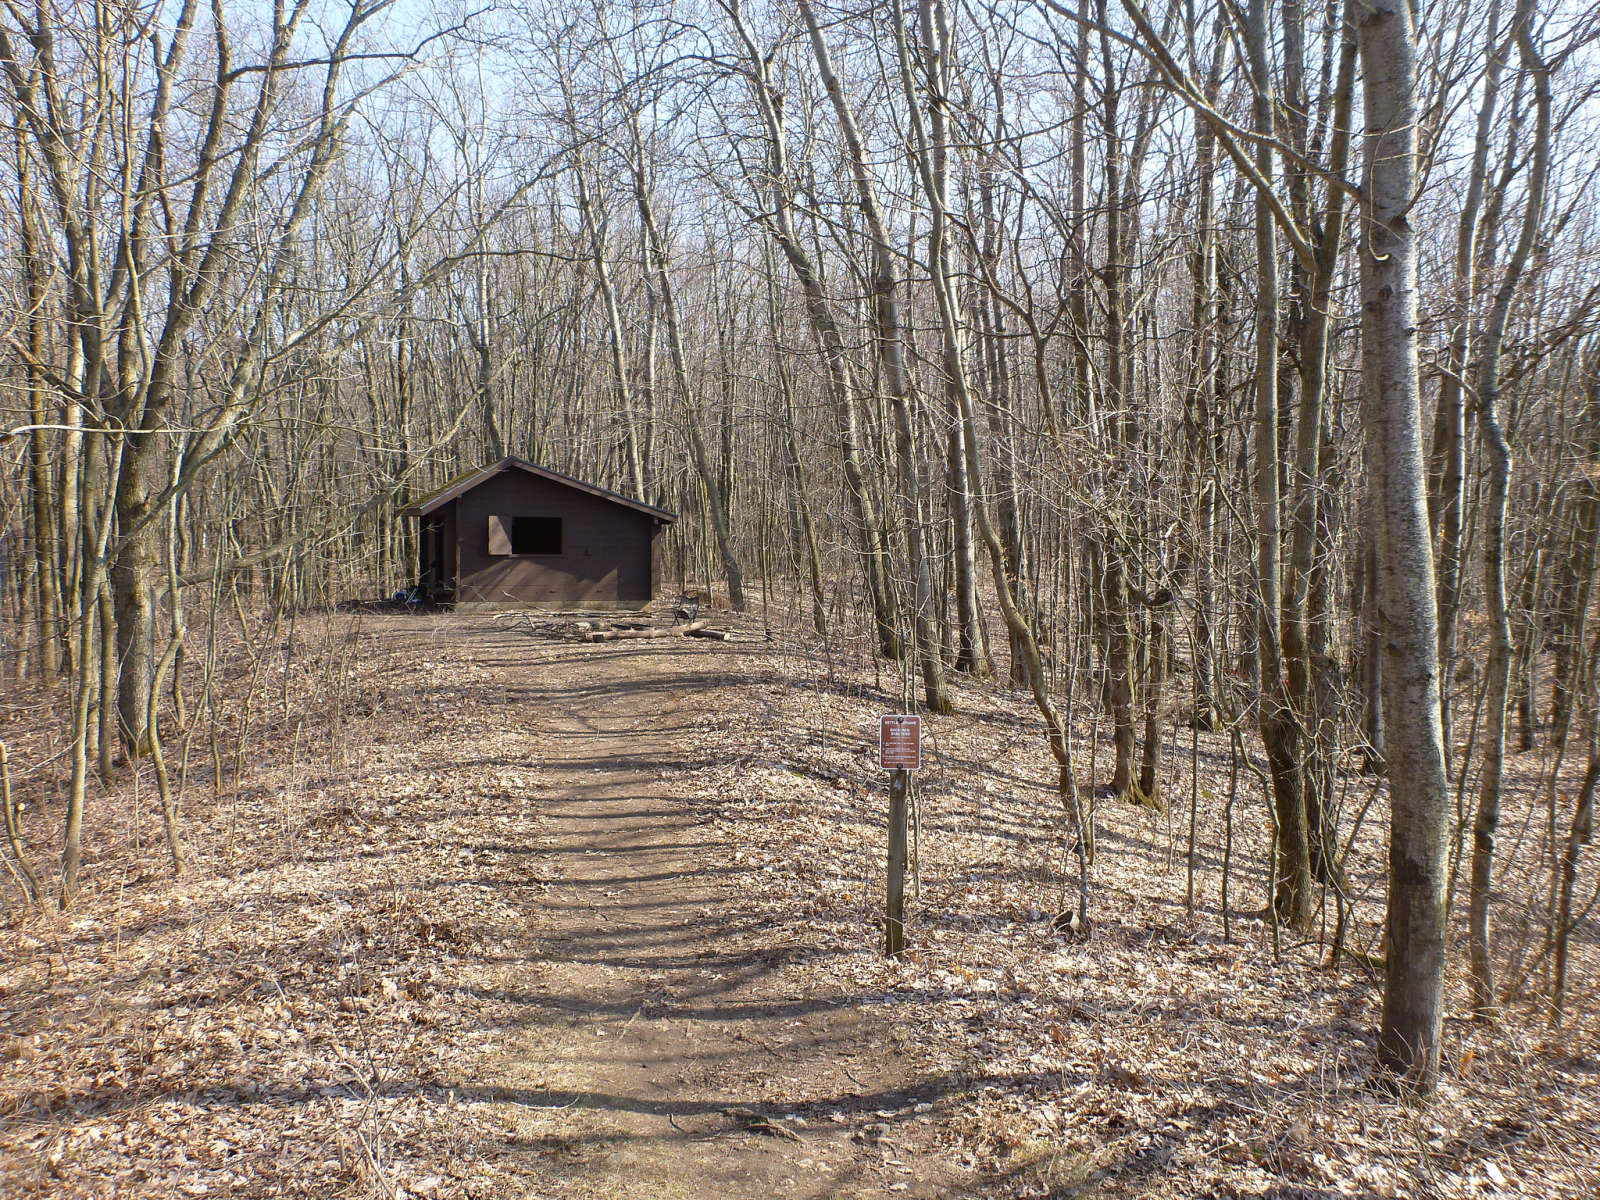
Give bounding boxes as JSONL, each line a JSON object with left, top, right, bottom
{"left": 445, "top": 469, "right": 658, "bottom": 605}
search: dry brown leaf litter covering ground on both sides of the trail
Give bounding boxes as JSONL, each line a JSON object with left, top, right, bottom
{"left": 0, "top": 616, "right": 1600, "bottom": 1197}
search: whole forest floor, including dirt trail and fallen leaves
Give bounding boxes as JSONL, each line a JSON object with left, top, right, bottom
{"left": 0, "top": 614, "right": 1600, "bottom": 1200}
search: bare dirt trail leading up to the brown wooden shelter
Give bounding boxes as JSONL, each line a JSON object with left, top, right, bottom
{"left": 454, "top": 634, "right": 955, "bottom": 1200}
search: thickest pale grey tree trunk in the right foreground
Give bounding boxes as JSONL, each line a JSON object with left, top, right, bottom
{"left": 1357, "top": 0, "right": 1450, "bottom": 1091}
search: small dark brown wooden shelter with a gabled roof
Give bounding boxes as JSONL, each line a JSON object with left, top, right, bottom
{"left": 400, "top": 458, "right": 677, "bottom": 608}
